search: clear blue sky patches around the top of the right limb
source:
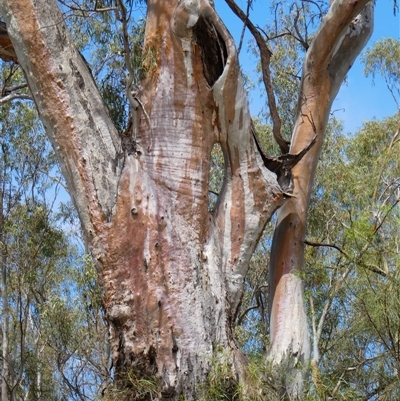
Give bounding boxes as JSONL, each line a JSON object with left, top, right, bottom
{"left": 215, "top": 0, "right": 400, "bottom": 132}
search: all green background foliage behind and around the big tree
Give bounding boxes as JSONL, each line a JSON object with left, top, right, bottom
{"left": 4, "top": 0, "right": 400, "bottom": 401}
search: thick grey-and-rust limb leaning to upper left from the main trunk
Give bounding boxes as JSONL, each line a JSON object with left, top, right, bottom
{"left": 0, "top": 0, "right": 122, "bottom": 235}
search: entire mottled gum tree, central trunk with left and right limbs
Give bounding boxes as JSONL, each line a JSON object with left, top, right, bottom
{"left": 0, "top": 0, "right": 373, "bottom": 400}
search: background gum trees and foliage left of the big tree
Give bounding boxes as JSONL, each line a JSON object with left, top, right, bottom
{"left": 0, "top": 63, "right": 109, "bottom": 401}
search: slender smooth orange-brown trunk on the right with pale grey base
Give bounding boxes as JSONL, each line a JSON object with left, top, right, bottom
{"left": 268, "top": 0, "right": 373, "bottom": 398}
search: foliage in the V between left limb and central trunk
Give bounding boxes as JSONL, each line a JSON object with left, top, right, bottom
{"left": 60, "top": 0, "right": 148, "bottom": 133}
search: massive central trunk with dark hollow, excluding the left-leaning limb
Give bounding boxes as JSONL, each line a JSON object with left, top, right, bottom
{"left": 99, "top": 1, "right": 282, "bottom": 399}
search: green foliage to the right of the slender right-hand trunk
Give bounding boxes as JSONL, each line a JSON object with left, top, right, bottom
{"left": 304, "top": 112, "right": 400, "bottom": 400}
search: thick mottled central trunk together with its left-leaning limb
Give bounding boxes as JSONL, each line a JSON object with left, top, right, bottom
{"left": 1, "top": 0, "right": 284, "bottom": 400}
